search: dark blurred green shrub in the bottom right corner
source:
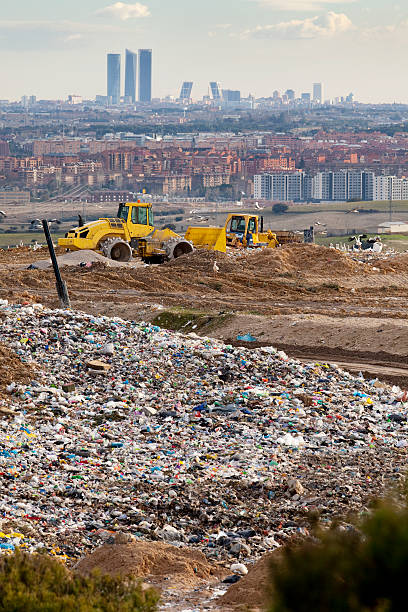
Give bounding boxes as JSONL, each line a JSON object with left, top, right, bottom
{"left": 270, "top": 504, "right": 408, "bottom": 612}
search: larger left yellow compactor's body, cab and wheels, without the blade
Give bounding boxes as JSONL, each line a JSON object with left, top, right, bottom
{"left": 58, "top": 202, "right": 194, "bottom": 263}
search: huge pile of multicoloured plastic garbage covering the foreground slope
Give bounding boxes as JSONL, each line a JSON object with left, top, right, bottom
{"left": 0, "top": 300, "right": 408, "bottom": 562}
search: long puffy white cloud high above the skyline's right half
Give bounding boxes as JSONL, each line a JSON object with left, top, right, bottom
{"left": 242, "top": 11, "right": 354, "bottom": 39}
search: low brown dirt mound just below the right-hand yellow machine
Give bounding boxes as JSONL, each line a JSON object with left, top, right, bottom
{"left": 246, "top": 244, "right": 369, "bottom": 276}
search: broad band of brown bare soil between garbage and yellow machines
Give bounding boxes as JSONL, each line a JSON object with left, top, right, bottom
{"left": 0, "top": 245, "right": 408, "bottom": 386}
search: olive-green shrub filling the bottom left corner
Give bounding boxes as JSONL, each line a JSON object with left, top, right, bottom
{"left": 0, "top": 551, "right": 158, "bottom": 612}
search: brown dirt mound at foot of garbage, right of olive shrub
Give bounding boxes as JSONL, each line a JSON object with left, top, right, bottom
{"left": 76, "top": 542, "right": 223, "bottom": 587}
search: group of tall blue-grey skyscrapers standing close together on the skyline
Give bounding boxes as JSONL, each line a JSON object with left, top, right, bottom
{"left": 107, "top": 49, "right": 152, "bottom": 105}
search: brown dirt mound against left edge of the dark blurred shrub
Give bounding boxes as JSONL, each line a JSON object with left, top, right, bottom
{"left": 217, "top": 552, "right": 278, "bottom": 610}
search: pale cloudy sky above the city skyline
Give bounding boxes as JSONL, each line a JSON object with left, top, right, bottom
{"left": 0, "top": 0, "right": 408, "bottom": 103}
